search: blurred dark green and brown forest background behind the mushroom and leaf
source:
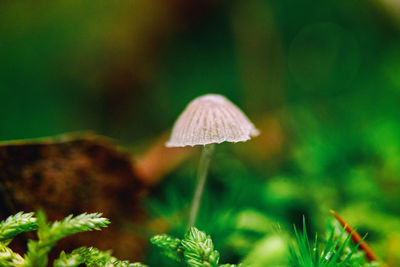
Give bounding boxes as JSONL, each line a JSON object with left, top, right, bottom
{"left": 0, "top": 0, "right": 400, "bottom": 266}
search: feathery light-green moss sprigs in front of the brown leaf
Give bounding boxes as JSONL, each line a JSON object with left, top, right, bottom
{"left": 0, "top": 211, "right": 145, "bottom": 267}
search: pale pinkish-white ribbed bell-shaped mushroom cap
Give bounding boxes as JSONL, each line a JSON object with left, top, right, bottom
{"left": 166, "top": 94, "right": 259, "bottom": 147}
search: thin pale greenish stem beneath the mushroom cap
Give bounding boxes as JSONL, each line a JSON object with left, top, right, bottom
{"left": 187, "top": 144, "right": 215, "bottom": 230}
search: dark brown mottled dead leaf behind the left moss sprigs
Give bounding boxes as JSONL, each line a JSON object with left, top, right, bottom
{"left": 0, "top": 135, "right": 145, "bottom": 260}
